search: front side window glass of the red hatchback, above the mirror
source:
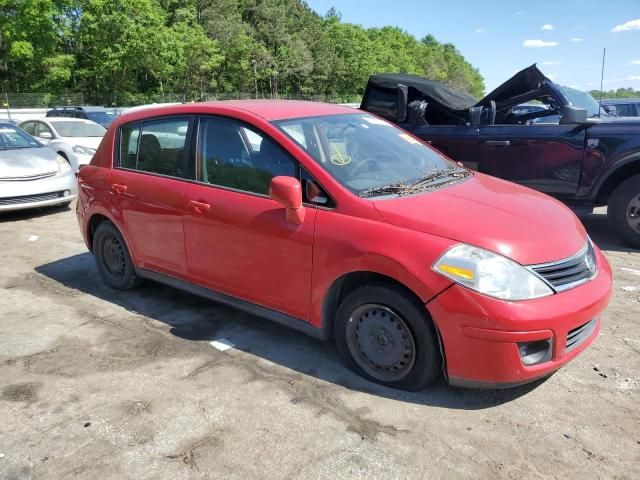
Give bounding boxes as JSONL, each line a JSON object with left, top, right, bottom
{"left": 198, "top": 118, "right": 297, "bottom": 195}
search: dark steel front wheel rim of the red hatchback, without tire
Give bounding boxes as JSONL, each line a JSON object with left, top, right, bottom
{"left": 346, "top": 303, "right": 416, "bottom": 382}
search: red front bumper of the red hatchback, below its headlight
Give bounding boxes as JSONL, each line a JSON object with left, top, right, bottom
{"left": 427, "top": 248, "right": 612, "bottom": 388}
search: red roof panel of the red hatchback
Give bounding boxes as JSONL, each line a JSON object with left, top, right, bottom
{"left": 120, "top": 100, "right": 358, "bottom": 120}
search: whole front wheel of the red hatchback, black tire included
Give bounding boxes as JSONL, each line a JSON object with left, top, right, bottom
{"left": 334, "top": 283, "right": 442, "bottom": 391}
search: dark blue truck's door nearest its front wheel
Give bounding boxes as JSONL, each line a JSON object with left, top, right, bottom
{"left": 478, "top": 123, "right": 585, "bottom": 198}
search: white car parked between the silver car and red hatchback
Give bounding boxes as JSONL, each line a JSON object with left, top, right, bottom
{"left": 20, "top": 117, "right": 107, "bottom": 173}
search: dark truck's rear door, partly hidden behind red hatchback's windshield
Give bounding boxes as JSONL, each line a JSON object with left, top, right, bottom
{"left": 400, "top": 125, "right": 478, "bottom": 170}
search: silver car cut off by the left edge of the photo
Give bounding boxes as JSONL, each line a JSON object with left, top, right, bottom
{"left": 0, "top": 122, "right": 77, "bottom": 212}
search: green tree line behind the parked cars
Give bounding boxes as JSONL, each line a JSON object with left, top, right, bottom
{"left": 0, "top": 0, "right": 484, "bottom": 105}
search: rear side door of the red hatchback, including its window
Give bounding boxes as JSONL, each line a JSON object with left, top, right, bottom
{"left": 109, "top": 116, "right": 195, "bottom": 278}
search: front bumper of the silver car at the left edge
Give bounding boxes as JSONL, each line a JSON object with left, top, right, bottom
{"left": 0, "top": 171, "right": 78, "bottom": 212}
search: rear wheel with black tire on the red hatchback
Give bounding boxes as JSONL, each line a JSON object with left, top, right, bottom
{"left": 93, "top": 221, "right": 142, "bottom": 290}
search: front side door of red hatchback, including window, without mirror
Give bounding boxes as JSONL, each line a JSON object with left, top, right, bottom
{"left": 184, "top": 117, "right": 316, "bottom": 320}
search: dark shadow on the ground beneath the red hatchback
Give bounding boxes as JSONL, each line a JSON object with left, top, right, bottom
{"left": 36, "top": 249, "right": 544, "bottom": 410}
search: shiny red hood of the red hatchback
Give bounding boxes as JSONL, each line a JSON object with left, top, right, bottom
{"left": 373, "top": 173, "right": 587, "bottom": 265}
